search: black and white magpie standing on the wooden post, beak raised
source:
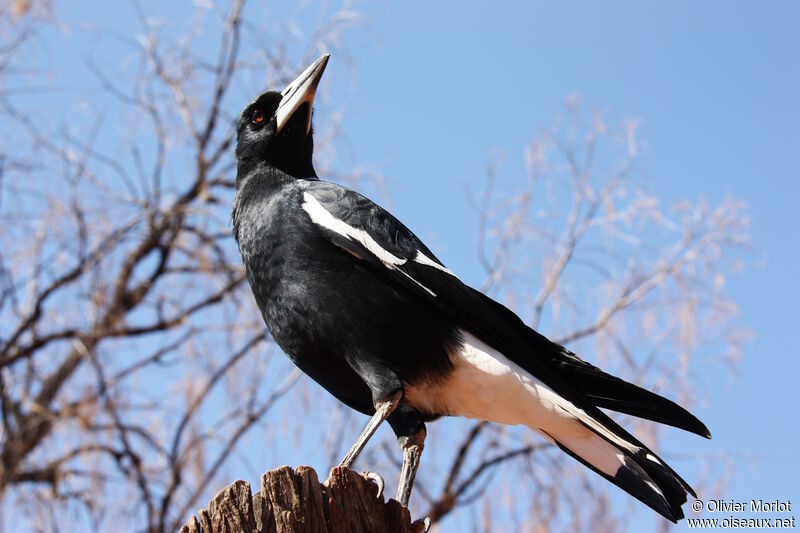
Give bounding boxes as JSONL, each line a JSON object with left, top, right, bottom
{"left": 232, "top": 55, "right": 711, "bottom": 521}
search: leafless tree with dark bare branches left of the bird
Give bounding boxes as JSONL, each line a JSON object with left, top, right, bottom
{"left": 0, "top": 0, "right": 372, "bottom": 531}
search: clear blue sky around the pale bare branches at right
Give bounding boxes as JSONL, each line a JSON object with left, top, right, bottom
{"left": 7, "top": 0, "right": 800, "bottom": 529}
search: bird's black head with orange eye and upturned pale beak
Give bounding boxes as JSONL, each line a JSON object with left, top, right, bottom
{"left": 236, "top": 54, "right": 330, "bottom": 183}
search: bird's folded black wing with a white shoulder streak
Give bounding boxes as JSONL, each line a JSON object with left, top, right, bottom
{"left": 304, "top": 182, "right": 711, "bottom": 438}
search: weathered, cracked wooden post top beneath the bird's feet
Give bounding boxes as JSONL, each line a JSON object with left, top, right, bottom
{"left": 181, "top": 466, "right": 424, "bottom": 533}
